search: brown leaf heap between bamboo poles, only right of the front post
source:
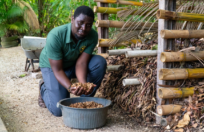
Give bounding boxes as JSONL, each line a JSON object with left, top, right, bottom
{"left": 159, "top": 39, "right": 204, "bottom": 132}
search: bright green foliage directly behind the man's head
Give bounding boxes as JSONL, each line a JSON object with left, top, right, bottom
{"left": 28, "top": 0, "right": 97, "bottom": 37}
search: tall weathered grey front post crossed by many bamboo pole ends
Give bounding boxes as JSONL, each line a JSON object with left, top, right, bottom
{"left": 156, "top": 0, "right": 176, "bottom": 124}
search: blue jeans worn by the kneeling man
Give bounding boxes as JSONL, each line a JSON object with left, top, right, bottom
{"left": 40, "top": 55, "right": 107, "bottom": 116}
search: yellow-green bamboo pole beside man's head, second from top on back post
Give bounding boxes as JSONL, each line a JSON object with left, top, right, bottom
{"left": 93, "top": 6, "right": 128, "bottom": 14}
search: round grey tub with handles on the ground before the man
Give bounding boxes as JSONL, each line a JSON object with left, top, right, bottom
{"left": 57, "top": 97, "right": 111, "bottom": 129}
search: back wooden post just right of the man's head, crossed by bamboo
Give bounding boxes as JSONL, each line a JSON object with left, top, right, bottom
{"left": 97, "top": 2, "right": 109, "bottom": 54}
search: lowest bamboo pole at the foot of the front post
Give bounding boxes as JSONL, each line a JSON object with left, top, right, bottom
{"left": 157, "top": 104, "right": 182, "bottom": 116}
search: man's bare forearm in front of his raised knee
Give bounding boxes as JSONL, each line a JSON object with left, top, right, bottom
{"left": 76, "top": 63, "right": 87, "bottom": 83}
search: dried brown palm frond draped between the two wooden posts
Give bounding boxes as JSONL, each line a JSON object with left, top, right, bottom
{"left": 109, "top": 2, "right": 159, "bottom": 46}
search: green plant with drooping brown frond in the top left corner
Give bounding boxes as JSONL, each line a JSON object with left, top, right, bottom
{"left": 0, "top": 0, "right": 39, "bottom": 37}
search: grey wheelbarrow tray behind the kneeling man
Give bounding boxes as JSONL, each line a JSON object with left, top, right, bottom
{"left": 21, "top": 36, "right": 46, "bottom": 59}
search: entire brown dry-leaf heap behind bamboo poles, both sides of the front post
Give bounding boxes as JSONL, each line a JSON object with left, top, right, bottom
{"left": 99, "top": 40, "right": 204, "bottom": 132}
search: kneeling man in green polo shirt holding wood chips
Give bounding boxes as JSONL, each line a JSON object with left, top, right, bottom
{"left": 38, "top": 6, "right": 107, "bottom": 116}
